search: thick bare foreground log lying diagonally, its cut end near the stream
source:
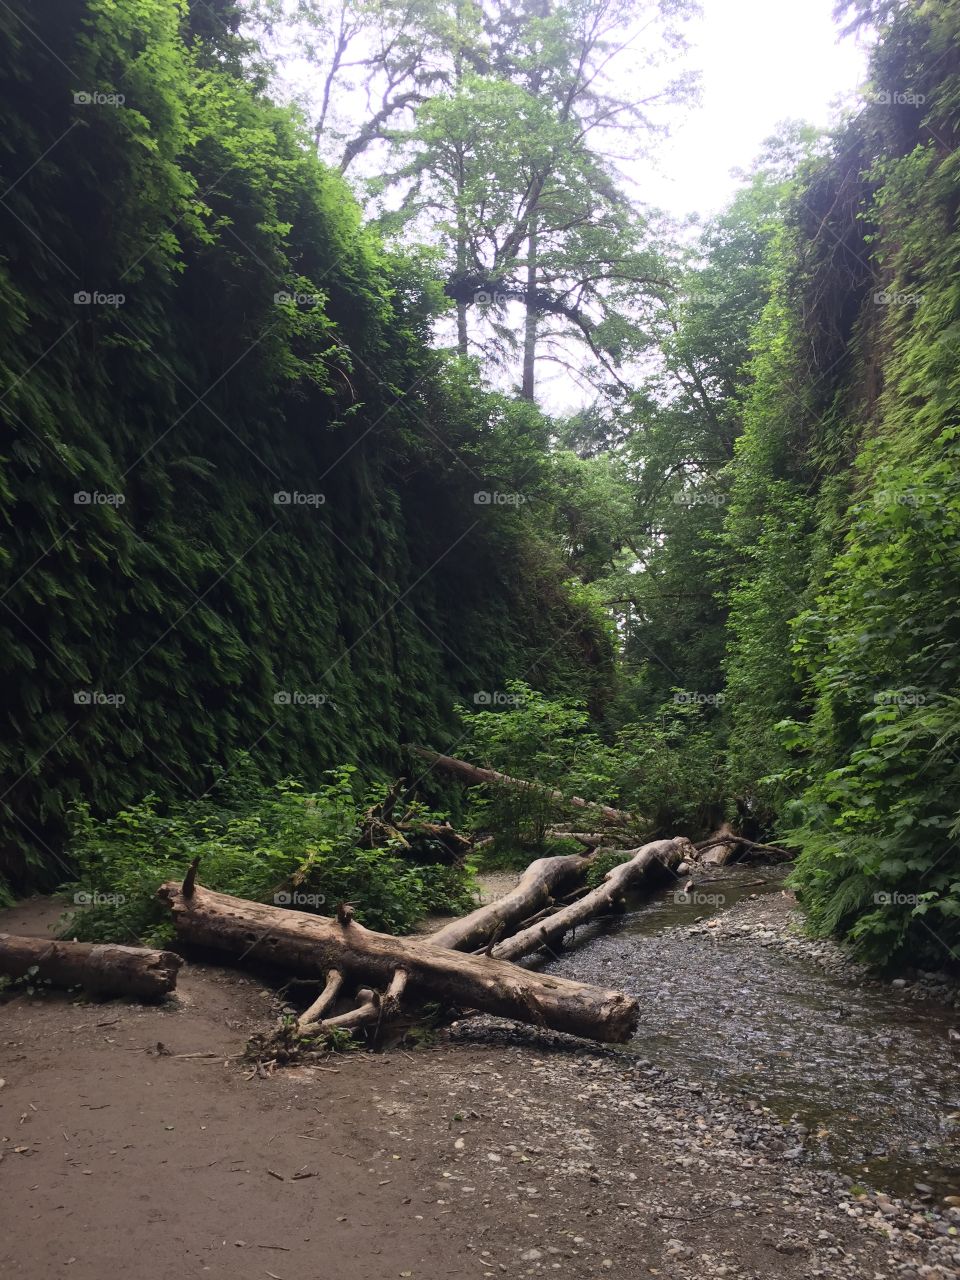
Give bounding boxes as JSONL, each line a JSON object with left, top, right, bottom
{"left": 159, "top": 882, "right": 639, "bottom": 1043}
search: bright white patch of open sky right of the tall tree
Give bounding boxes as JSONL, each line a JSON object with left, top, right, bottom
{"left": 644, "top": 0, "right": 867, "bottom": 215}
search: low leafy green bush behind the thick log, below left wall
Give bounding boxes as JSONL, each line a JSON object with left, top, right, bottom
{"left": 64, "top": 762, "right": 472, "bottom": 945}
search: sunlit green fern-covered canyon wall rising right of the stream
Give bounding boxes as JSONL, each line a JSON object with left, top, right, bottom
{"left": 727, "top": 4, "right": 960, "bottom": 966}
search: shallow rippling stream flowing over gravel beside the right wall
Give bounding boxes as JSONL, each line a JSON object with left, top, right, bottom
{"left": 549, "top": 868, "right": 960, "bottom": 1197}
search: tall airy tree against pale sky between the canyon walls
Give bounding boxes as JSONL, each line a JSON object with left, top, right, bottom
{"left": 252, "top": 0, "right": 691, "bottom": 398}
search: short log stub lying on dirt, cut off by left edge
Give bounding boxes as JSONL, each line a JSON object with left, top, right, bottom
{"left": 0, "top": 933, "right": 183, "bottom": 1000}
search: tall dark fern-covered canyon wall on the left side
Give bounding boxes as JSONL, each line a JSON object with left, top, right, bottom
{"left": 0, "top": 0, "right": 611, "bottom": 888}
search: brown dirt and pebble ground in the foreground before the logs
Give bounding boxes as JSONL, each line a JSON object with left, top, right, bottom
{"left": 0, "top": 899, "right": 960, "bottom": 1280}
